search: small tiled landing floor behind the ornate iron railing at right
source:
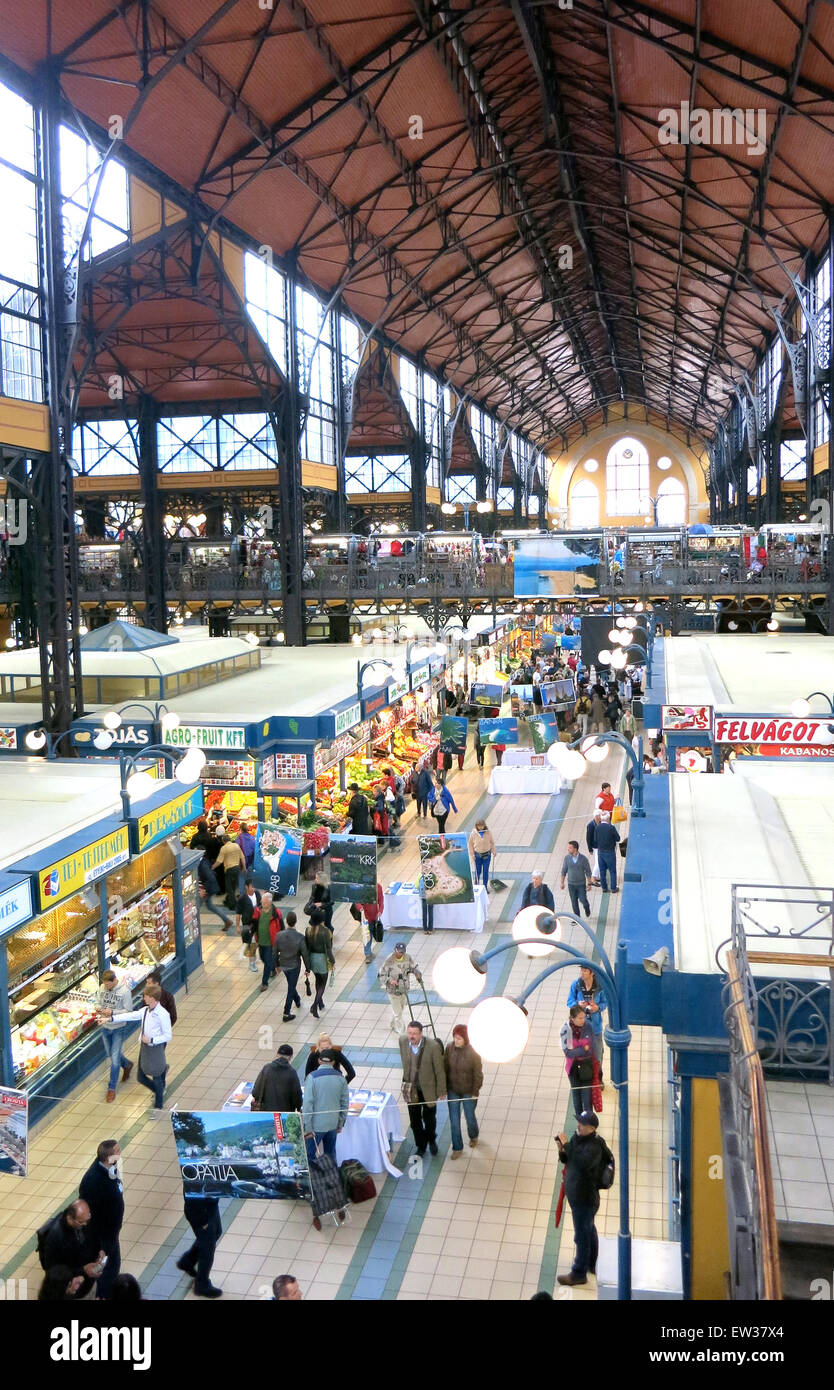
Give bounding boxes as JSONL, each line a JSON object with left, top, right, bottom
{"left": 767, "top": 1081, "right": 834, "bottom": 1226}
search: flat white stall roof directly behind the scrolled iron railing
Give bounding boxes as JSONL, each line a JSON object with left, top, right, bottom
{"left": 670, "top": 762, "right": 834, "bottom": 979}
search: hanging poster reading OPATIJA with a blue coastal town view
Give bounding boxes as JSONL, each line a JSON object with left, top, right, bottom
{"left": 171, "top": 1111, "right": 311, "bottom": 1201}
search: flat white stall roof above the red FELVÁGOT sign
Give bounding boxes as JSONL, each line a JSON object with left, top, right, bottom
{"left": 664, "top": 631, "right": 834, "bottom": 714}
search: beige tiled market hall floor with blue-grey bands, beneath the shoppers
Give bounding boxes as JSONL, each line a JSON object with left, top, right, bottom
{"left": 0, "top": 751, "right": 667, "bottom": 1300}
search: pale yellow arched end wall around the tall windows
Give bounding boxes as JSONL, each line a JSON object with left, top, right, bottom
{"left": 548, "top": 420, "right": 709, "bottom": 528}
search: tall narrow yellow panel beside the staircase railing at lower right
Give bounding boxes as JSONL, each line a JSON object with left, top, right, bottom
{"left": 691, "top": 1077, "right": 730, "bottom": 1301}
